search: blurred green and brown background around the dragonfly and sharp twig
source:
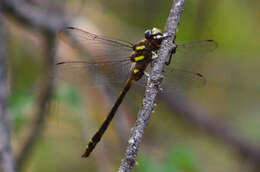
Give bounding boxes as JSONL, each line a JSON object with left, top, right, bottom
{"left": 3, "top": 0, "right": 260, "bottom": 172}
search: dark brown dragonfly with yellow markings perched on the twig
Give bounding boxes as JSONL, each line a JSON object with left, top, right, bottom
{"left": 56, "top": 27, "right": 217, "bottom": 158}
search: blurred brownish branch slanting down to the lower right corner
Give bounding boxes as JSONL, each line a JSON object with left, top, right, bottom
{"left": 160, "top": 92, "right": 260, "bottom": 170}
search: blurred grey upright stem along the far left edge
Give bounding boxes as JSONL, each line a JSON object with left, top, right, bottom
{"left": 0, "top": 11, "right": 15, "bottom": 172}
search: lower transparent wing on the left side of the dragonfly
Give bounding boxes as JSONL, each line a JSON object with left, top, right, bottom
{"left": 56, "top": 60, "right": 131, "bottom": 85}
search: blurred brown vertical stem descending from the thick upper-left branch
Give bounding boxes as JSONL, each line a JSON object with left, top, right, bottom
{"left": 17, "top": 33, "right": 56, "bottom": 171}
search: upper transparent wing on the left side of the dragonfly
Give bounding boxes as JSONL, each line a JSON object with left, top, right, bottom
{"left": 59, "top": 27, "right": 133, "bottom": 61}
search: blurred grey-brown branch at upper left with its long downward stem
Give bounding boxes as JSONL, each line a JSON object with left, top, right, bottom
{"left": 0, "top": 0, "right": 68, "bottom": 169}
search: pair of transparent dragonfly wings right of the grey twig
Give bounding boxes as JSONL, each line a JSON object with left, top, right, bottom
{"left": 165, "top": 40, "right": 217, "bottom": 89}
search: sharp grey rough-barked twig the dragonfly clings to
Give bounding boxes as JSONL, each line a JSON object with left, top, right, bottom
{"left": 118, "top": 0, "right": 184, "bottom": 172}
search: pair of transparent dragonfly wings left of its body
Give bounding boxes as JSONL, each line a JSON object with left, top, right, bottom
{"left": 56, "top": 27, "right": 133, "bottom": 83}
